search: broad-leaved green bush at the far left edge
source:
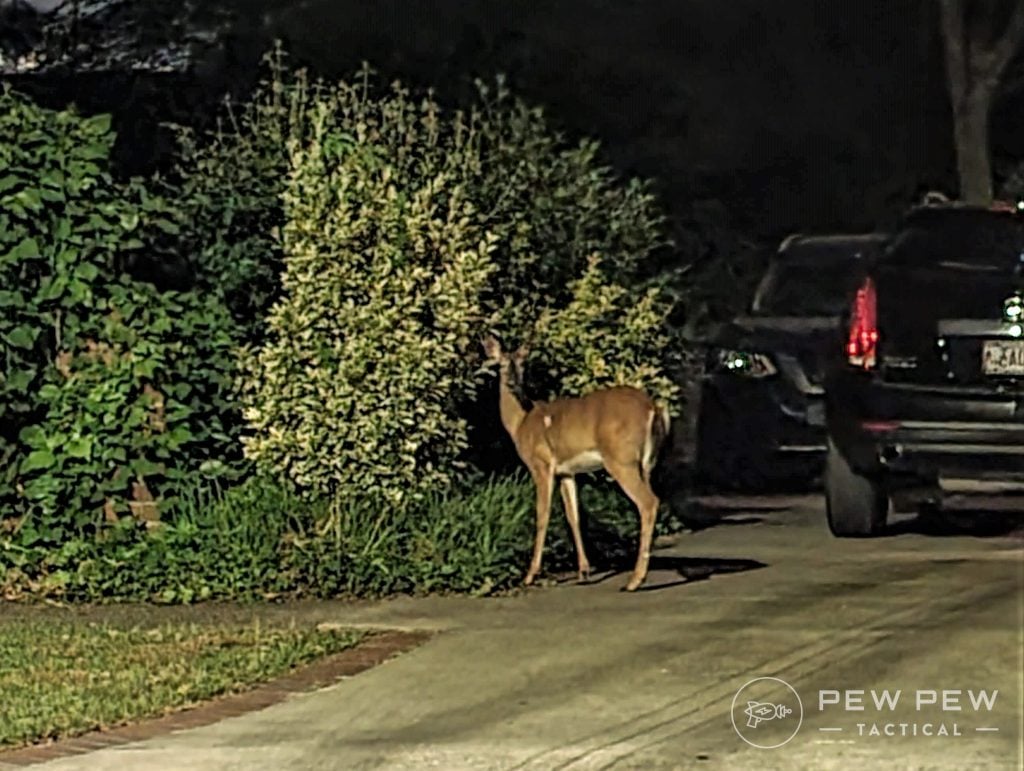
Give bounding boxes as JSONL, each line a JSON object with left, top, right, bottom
{"left": 0, "top": 83, "right": 238, "bottom": 546}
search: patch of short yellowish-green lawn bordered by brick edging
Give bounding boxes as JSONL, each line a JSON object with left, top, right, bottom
{"left": 0, "top": 617, "right": 364, "bottom": 747}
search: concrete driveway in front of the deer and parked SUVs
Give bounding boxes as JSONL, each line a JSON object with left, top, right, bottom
{"left": 32, "top": 497, "right": 1024, "bottom": 771}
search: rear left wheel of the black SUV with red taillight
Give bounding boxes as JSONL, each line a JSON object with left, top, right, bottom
{"left": 824, "top": 438, "right": 889, "bottom": 538}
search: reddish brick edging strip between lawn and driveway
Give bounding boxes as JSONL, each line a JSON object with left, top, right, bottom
{"left": 0, "top": 631, "right": 433, "bottom": 769}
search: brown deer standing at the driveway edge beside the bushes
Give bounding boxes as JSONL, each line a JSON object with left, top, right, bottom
{"left": 483, "top": 337, "right": 669, "bottom": 592}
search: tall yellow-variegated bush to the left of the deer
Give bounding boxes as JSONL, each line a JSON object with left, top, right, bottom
{"left": 236, "top": 86, "right": 494, "bottom": 503}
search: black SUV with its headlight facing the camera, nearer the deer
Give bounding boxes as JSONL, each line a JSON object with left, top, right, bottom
{"left": 695, "top": 233, "right": 885, "bottom": 491}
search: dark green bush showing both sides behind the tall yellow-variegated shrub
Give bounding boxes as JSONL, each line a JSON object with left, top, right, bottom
{"left": 171, "top": 48, "right": 676, "bottom": 346}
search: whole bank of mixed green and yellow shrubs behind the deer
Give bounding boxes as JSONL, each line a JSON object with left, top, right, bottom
{"left": 0, "top": 45, "right": 692, "bottom": 602}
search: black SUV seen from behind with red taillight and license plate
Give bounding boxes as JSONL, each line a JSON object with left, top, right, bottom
{"left": 824, "top": 201, "right": 1024, "bottom": 537}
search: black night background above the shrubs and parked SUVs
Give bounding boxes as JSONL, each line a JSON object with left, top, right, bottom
{"left": 7, "top": 0, "right": 1024, "bottom": 243}
